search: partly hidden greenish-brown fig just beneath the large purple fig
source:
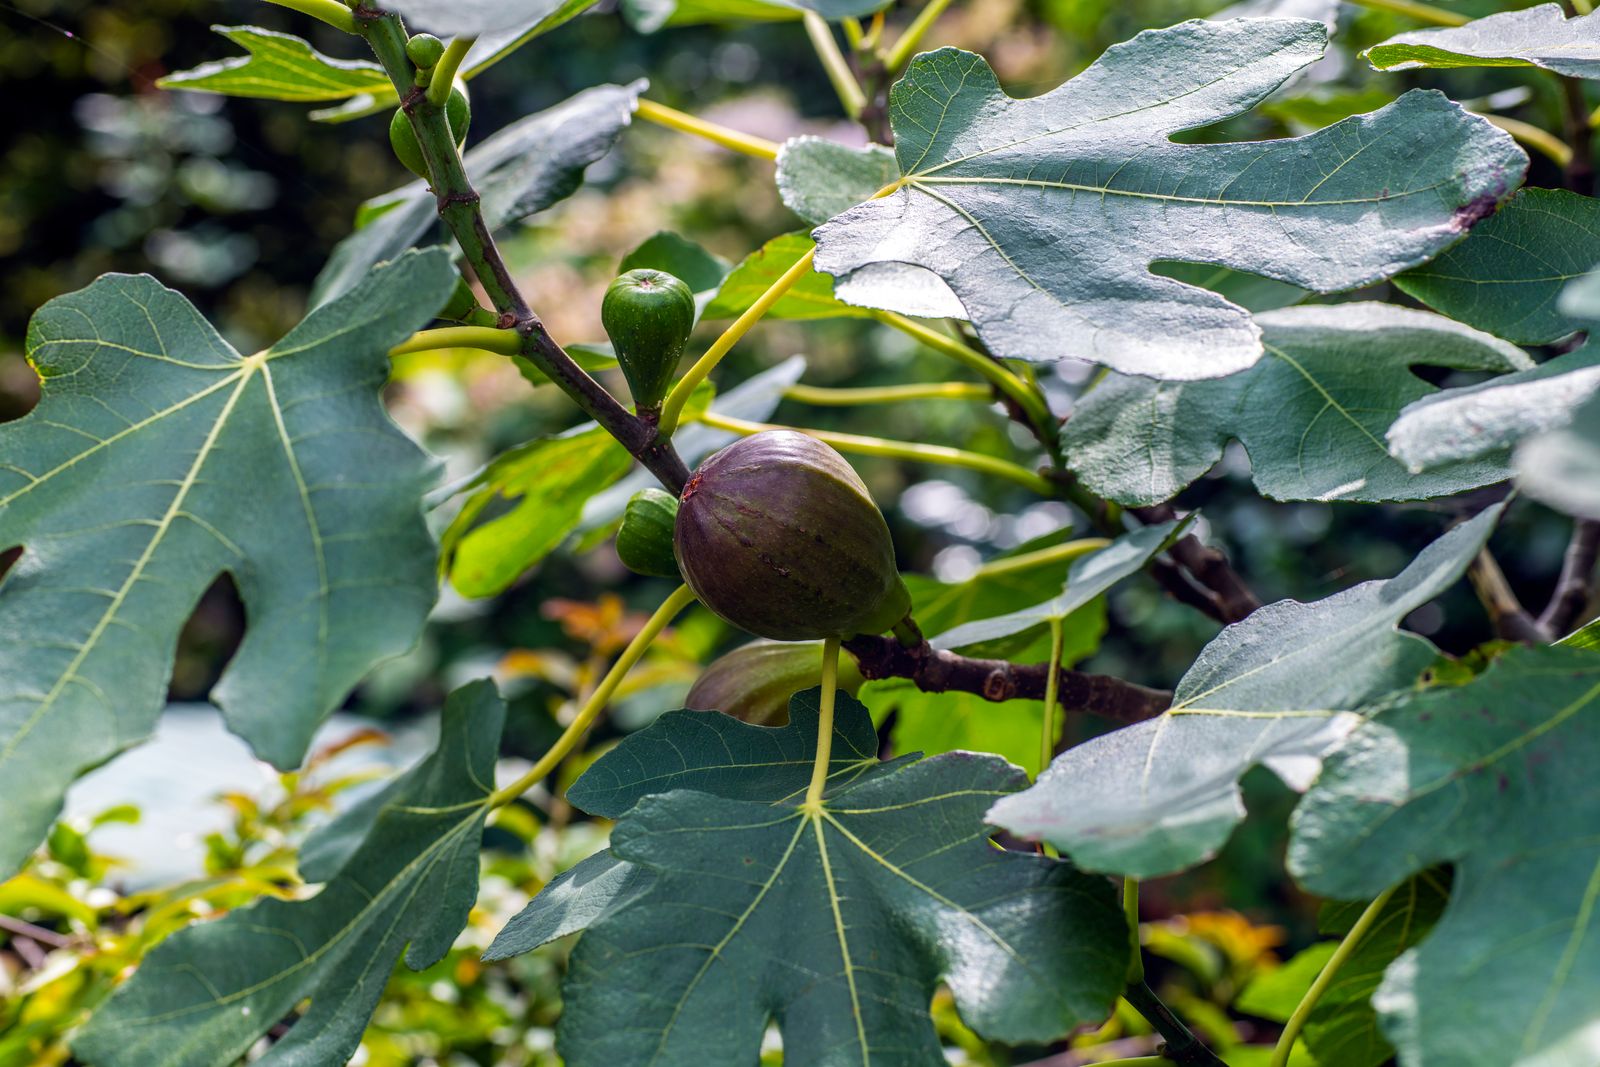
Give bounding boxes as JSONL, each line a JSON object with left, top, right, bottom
{"left": 683, "top": 638, "right": 862, "bottom": 726}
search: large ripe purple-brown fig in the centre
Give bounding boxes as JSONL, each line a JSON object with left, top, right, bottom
{"left": 674, "top": 430, "right": 910, "bottom": 641}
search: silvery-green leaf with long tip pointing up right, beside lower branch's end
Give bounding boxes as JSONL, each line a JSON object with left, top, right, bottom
{"left": 989, "top": 506, "right": 1502, "bottom": 896}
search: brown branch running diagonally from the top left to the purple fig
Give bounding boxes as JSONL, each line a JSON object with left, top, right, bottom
{"left": 352, "top": 5, "right": 690, "bottom": 493}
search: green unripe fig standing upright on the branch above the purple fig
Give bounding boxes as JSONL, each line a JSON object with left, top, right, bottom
{"left": 600, "top": 267, "right": 694, "bottom": 411}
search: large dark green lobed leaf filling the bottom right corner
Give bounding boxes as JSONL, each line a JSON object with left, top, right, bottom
{"left": 1290, "top": 648, "right": 1600, "bottom": 1067}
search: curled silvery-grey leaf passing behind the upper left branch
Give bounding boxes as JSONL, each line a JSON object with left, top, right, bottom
{"left": 312, "top": 82, "right": 645, "bottom": 304}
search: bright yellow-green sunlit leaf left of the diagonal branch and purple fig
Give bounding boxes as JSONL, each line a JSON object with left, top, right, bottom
{"left": 440, "top": 424, "right": 634, "bottom": 597}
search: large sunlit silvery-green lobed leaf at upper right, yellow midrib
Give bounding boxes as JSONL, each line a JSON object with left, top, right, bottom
{"left": 814, "top": 19, "right": 1526, "bottom": 379}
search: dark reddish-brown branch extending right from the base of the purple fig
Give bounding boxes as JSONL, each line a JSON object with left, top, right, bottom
{"left": 845, "top": 635, "right": 1173, "bottom": 723}
